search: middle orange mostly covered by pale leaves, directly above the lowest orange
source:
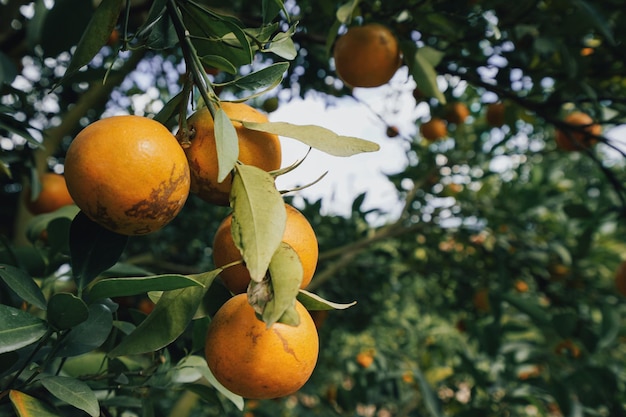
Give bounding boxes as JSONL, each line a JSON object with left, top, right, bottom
{"left": 213, "top": 204, "right": 319, "bottom": 294}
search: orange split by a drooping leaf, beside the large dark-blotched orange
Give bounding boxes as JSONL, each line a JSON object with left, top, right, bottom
{"left": 185, "top": 102, "right": 282, "bottom": 206}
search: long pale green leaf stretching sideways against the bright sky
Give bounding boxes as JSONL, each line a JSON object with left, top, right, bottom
{"left": 242, "top": 121, "right": 380, "bottom": 156}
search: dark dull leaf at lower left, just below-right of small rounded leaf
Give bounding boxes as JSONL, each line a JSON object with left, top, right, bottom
{"left": 59, "top": 303, "right": 113, "bottom": 357}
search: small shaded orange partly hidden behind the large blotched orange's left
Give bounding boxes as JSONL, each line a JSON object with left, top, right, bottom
{"left": 24, "top": 172, "right": 74, "bottom": 214}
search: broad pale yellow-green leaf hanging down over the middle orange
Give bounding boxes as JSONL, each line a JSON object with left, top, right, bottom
{"left": 231, "top": 164, "right": 287, "bottom": 282}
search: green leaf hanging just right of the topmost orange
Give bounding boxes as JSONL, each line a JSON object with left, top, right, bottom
{"left": 401, "top": 43, "right": 446, "bottom": 104}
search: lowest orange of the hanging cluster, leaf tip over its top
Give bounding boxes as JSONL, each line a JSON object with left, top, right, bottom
{"left": 205, "top": 294, "right": 319, "bottom": 399}
